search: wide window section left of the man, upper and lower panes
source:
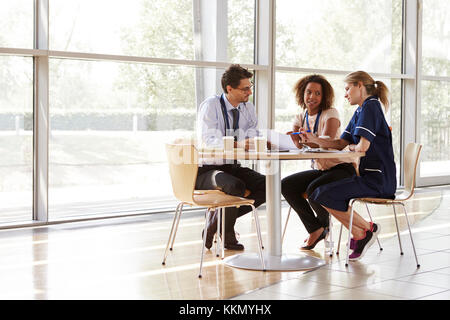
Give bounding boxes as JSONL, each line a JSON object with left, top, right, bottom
{"left": 49, "top": 0, "right": 254, "bottom": 220}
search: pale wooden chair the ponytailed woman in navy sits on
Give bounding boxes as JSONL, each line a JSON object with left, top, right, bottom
{"left": 338, "top": 143, "right": 422, "bottom": 268}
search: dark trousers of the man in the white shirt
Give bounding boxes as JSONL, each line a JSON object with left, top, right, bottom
{"left": 195, "top": 164, "right": 266, "bottom": 233}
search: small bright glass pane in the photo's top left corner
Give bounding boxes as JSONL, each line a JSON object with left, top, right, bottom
{"left": 0, "top": 0, "right": 34, "bottom": 49}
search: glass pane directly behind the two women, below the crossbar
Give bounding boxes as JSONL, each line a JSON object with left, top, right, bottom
{"left": 275, "top": 72, "right": 401, "bottom": 183}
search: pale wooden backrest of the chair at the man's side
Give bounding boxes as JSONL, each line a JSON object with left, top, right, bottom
{"left": 166, "top": 143, "right": 198, "bottom": 203}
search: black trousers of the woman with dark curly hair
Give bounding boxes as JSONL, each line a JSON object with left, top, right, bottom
{"left": 281, "top": 163, "right": 356, "bottom": 233}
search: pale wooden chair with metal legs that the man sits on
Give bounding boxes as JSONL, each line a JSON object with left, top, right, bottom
{"left": 162, "top": 143, "right": 265, "bottom": 278}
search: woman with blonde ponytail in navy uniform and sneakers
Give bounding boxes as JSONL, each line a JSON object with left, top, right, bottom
{"left": 302, "top": 71, "right": 397, "bottom": 260}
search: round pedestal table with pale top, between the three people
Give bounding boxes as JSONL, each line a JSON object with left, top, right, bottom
{"left": 199, "top": 149, "right": 365, "bottom": 271}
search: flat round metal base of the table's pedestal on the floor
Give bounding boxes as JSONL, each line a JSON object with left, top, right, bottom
{"left": 224, "top": 253, "right": 325, "bottom": 271}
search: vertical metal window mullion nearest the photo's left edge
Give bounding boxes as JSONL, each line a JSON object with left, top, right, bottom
{"left": 33, "top": 0, "right": 50, "bottom": 222}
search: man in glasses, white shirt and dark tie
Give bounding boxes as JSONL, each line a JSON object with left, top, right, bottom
{"left": 195, "top": 65, "right": 266, "bottom": 250}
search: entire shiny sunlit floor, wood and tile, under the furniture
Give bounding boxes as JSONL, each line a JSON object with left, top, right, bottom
{"left": 0, "top": 187, "right": 450, "bottom": 300}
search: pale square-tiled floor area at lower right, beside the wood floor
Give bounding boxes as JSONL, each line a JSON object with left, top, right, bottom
{"left": 232, "top": 189, "right": 450, "bottom": 300}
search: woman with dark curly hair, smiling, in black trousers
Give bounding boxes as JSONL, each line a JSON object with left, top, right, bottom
{"left": 281, "top": 74, "right": 356, "bottom": 250}
